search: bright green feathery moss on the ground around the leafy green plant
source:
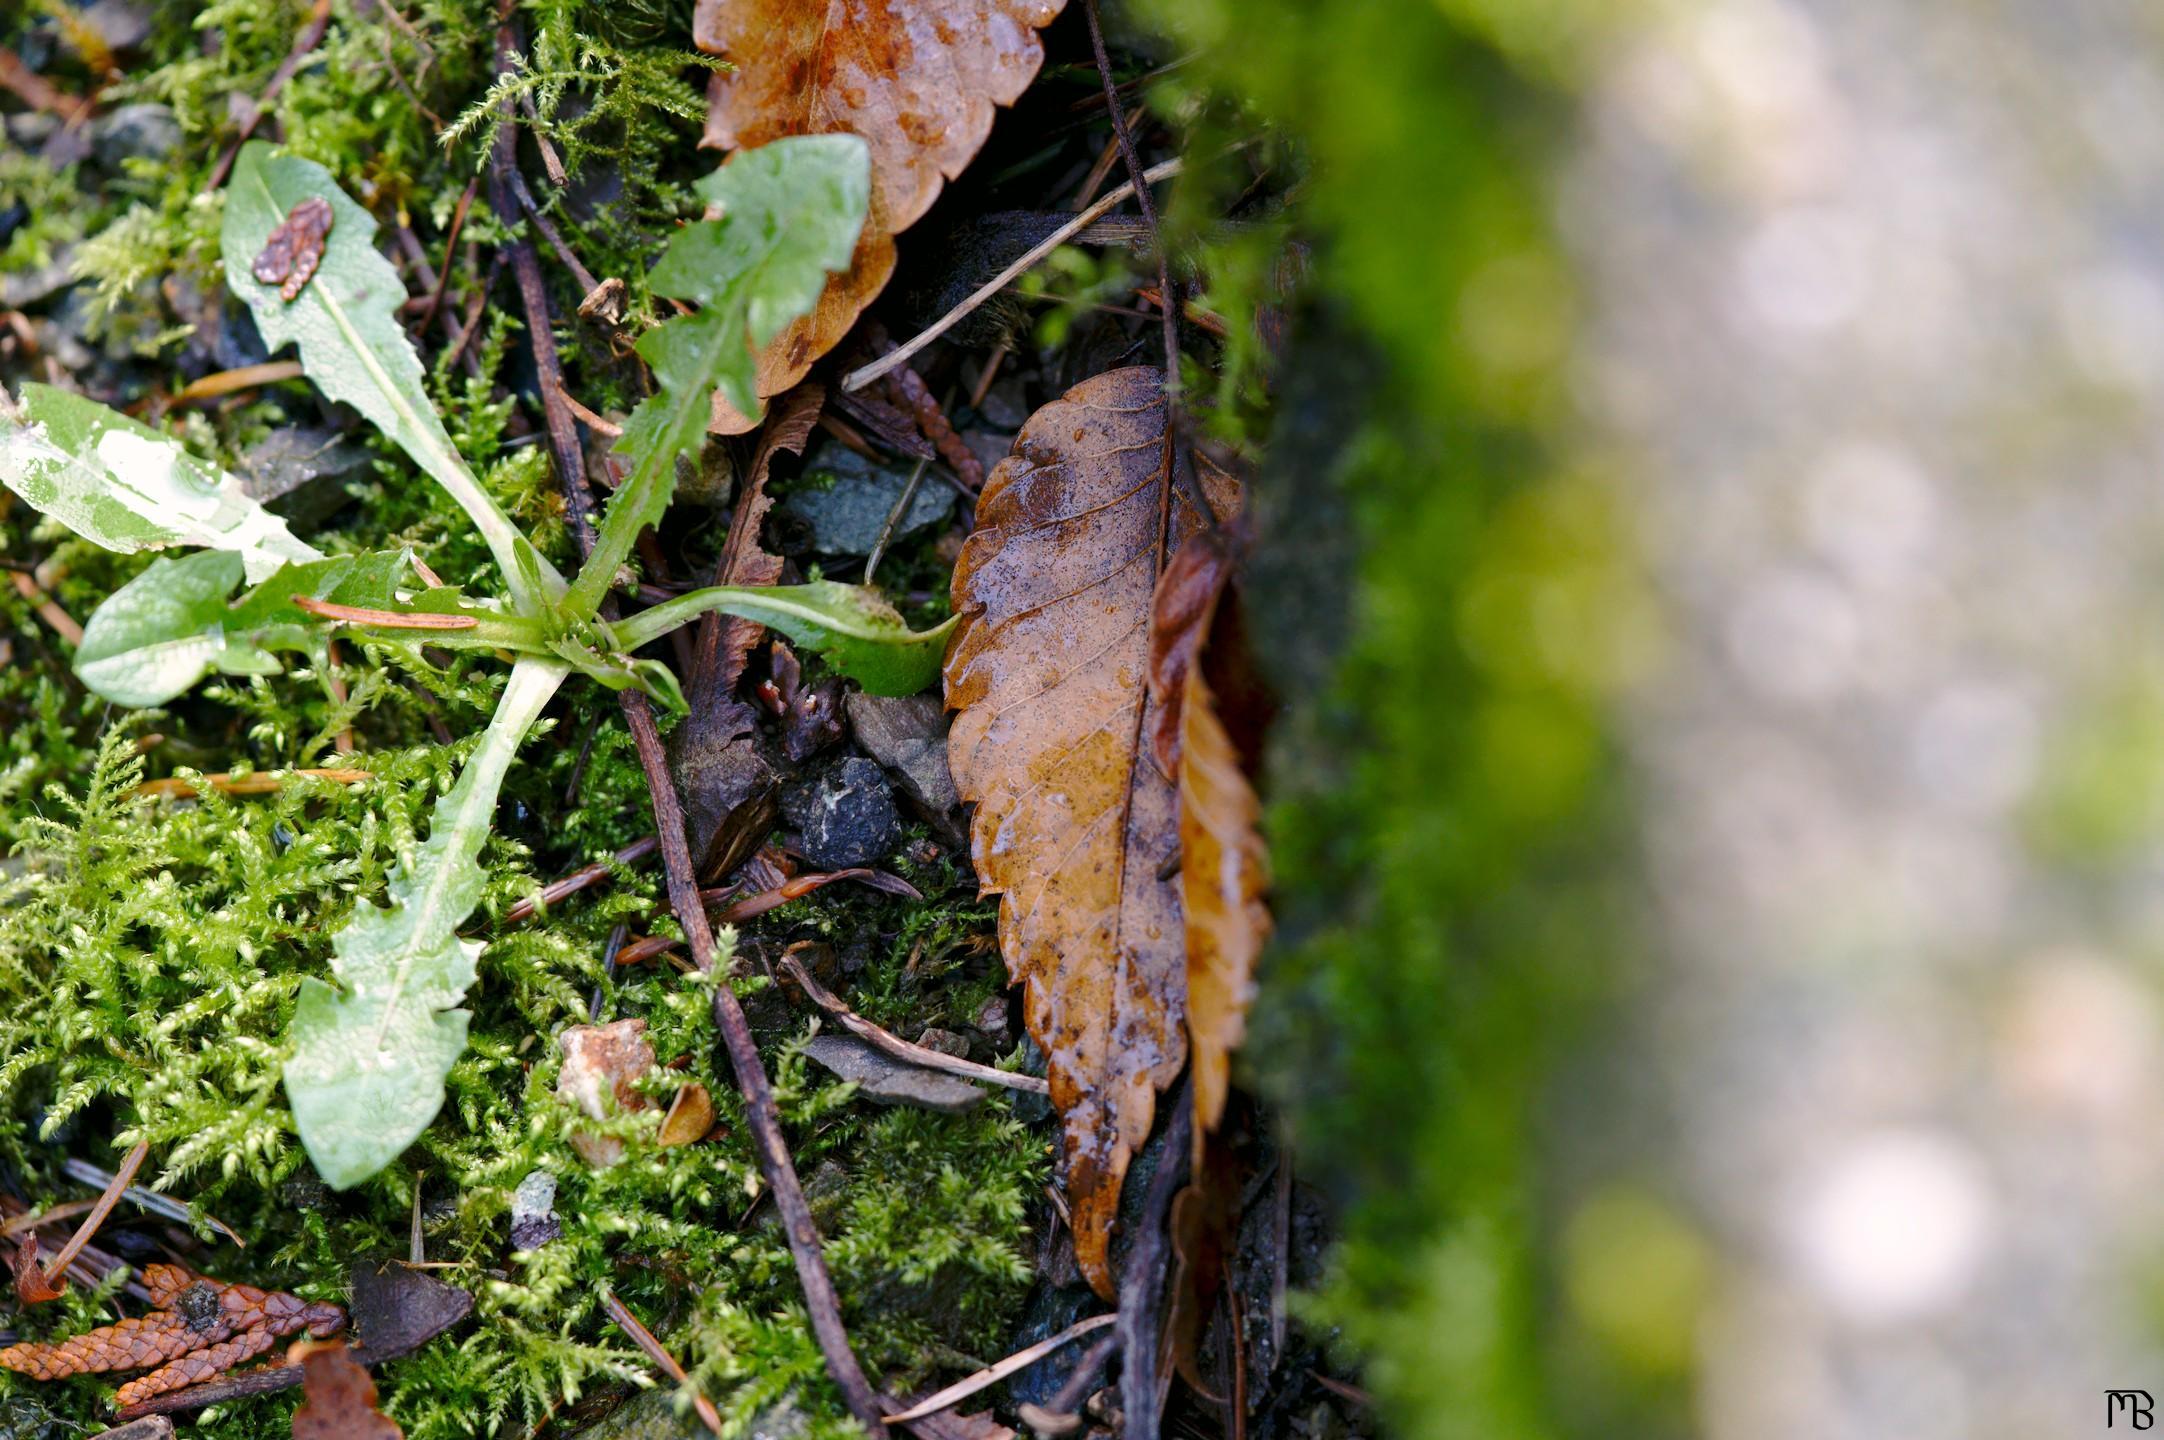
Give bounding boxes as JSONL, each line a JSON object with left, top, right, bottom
{"left": 0, "top": 0, "right": 1050, "bottom": 1440}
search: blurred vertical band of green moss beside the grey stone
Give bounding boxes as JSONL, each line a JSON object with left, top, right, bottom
{"left": 1143, "top": 0, "right": 1653, "bottom": 1440}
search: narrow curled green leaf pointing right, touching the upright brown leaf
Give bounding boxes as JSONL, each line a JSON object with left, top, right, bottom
{"left": 615, "top": 580, "right": 954, "bottom": 695}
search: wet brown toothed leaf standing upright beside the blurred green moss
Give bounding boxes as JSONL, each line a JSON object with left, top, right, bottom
{"left": 946, "top": 366, "right": 1205, "bottom": 1297}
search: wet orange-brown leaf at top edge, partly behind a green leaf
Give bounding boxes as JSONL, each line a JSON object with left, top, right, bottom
{"left": 692, "top": 0, "right": 1065, "bottom": 433}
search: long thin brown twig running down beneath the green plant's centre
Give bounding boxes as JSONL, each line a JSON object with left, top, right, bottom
{"left": 496, "top": 39, "right": 885, "bottom": 1434}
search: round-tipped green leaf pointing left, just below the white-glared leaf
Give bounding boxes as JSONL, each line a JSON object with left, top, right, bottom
{"left": 76, "top": 550, "right": 405, "bottom": 706}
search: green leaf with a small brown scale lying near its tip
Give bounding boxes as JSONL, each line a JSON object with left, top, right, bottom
{"left": 221, "top": 141, "right": 563, "bottom": 613}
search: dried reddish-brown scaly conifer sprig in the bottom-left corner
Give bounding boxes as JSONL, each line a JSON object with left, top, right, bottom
{"left": 0, "top": 1265, "right": 346, "bottom": 1410}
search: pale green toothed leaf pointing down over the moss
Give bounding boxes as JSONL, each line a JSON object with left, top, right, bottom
{"left": 286, "top": 660, "right": 569, "bottom": 1189}
